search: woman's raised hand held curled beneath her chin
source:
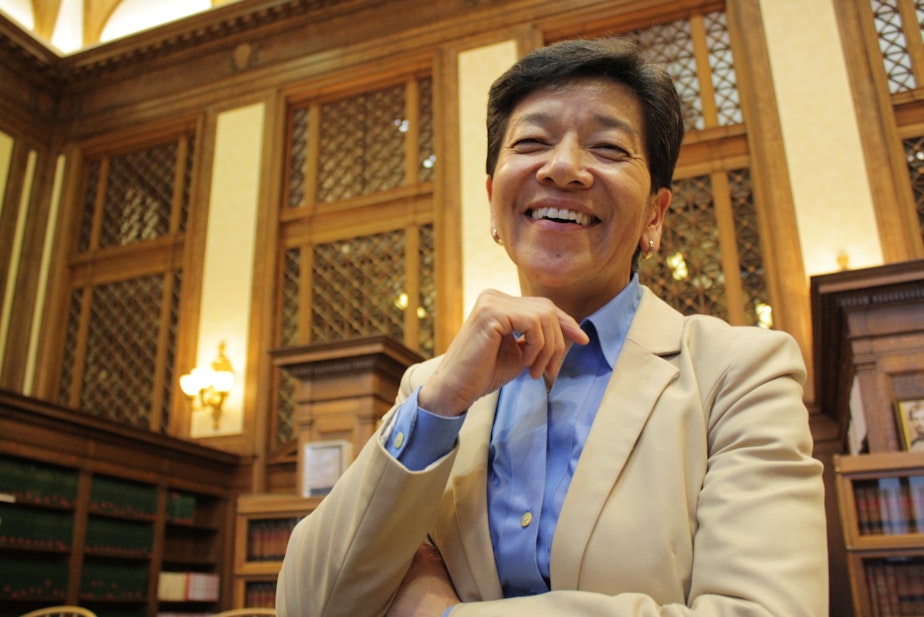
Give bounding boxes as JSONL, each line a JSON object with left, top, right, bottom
{"left": 418, "top": 290, "right": 589, "bottom": 416}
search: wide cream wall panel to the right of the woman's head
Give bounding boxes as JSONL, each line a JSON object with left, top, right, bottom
{"left": 760, "top": 0, "right": 883, "bottom": 276}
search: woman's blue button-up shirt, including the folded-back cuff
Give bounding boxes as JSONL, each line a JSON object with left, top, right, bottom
{"left": 386, "top": 276, "right": 642, "bottom": 597}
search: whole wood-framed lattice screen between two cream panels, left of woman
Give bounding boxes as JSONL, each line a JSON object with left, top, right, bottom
{"left": 271, "top": 76, "right": 437, "bottom": 446}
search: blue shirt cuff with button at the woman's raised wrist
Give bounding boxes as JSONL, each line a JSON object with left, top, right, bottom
{"left": 385, "top": 387, "right": 465, "bottom": 471}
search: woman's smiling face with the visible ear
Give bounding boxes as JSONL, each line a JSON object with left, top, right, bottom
{"left": 487, "top": 78, "right": 671, "bottom": 319}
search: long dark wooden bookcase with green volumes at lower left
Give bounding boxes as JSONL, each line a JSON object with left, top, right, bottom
{"left": 0, "top": 391, "right": 240, "bottom": 617}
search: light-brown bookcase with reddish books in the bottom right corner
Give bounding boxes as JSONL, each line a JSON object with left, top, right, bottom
{"left": 835, "top": 452, "right": 924, "bottom": 616}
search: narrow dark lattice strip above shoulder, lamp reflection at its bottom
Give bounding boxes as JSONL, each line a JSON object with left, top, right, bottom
{"left": 728, "top": 169, "right": 773, "bottom": 327}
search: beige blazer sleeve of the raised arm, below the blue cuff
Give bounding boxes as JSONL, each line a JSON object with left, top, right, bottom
{"left": 276, "top": 358, "right": 455, "bottom": 617}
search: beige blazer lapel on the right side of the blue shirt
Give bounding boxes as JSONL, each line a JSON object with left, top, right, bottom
{"left": 551, "top": 288, "right": 683, "bottom": 589}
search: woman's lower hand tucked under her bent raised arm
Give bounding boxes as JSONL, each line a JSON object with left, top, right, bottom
{"left": 386, "top": 543, "right": 459, "bottom": 617}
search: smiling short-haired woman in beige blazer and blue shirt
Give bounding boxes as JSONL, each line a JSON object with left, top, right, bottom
{"left": 277, "top": 39, "right": 827, "bottom": 617}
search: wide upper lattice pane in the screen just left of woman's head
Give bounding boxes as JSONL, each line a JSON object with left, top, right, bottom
{"left": 317, "top": 84, "right": 405, "bottom": 202}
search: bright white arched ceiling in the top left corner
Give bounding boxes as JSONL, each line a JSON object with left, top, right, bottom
{"left": 0, "top": 0, "right": 237, "bottom": 53}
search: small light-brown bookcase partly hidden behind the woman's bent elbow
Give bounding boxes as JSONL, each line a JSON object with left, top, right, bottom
{"left": 234, "top": 495, "right": 321, "bottom": 607}
